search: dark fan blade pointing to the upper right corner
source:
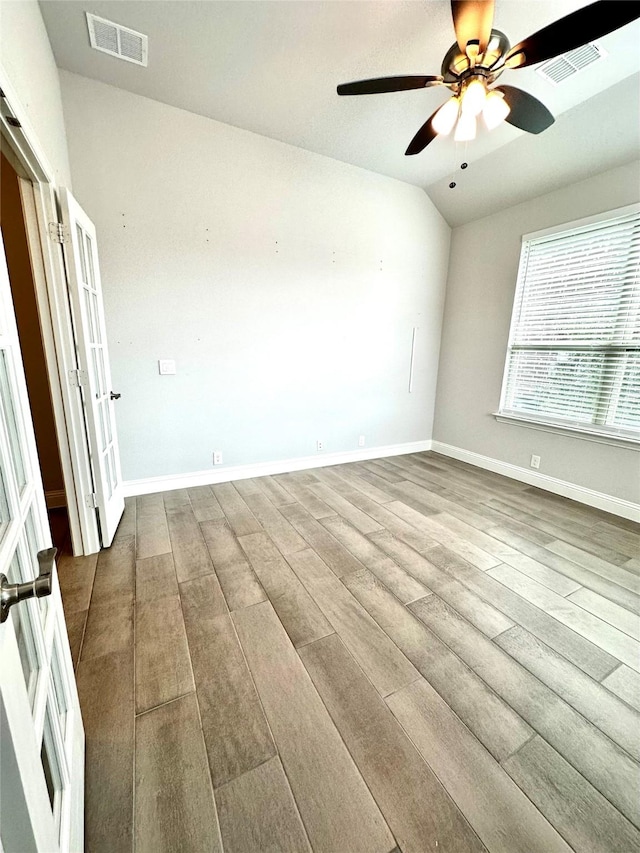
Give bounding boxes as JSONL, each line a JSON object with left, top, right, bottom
{"left": 505, "top": 0, "right": 640, "bottom": 68}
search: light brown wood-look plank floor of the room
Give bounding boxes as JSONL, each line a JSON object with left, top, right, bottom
{"left": 59, "top": 453, "right": 640, "bottom": 853}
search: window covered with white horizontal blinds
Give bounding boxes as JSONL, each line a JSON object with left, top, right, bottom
{"left": 498, "top": 205, "right": 640, "bottom": 440}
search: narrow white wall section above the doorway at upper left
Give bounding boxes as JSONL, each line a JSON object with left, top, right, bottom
{"left": 0, "top": 0, "right": 71, "bottom": 187}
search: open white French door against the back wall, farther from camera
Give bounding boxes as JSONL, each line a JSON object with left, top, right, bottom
{"left": 60, "top": 189, "right": 124, "bottom": 548}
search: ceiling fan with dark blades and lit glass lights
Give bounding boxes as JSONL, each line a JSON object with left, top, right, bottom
{"left": 338, "top": 0, "right": 640, "bottom": 155}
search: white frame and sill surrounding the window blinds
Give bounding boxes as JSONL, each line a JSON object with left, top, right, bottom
{"left": 493, "top": 203, "right": 640, "bottom": 447}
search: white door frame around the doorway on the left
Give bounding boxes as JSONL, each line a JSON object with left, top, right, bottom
{"left": 0, "top": 63, "right": 101, "bottom": 555}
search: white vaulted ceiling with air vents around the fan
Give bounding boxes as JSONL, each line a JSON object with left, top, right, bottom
{"left": 40, "top": 0, "right": 640, "bottom": 225}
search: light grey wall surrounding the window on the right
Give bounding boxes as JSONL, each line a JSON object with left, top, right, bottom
{"left": 433, "top": 163, "right": 640, "bottom": 502}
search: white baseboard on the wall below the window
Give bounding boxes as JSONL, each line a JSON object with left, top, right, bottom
{"left": 431, "top": 441, "right": 640, "bottom": 522}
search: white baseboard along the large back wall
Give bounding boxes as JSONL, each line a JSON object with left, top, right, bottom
{"left": 122, "top": 440, "right": 431, "bottom": 497}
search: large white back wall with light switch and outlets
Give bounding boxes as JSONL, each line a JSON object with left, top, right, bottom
{"left": 61, "top": 72, "right": 450, "bottom": 479}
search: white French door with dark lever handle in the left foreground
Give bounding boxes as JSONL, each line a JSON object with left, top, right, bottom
{"left": 0, "top": 230, "right": 84, "bottom": 853}
